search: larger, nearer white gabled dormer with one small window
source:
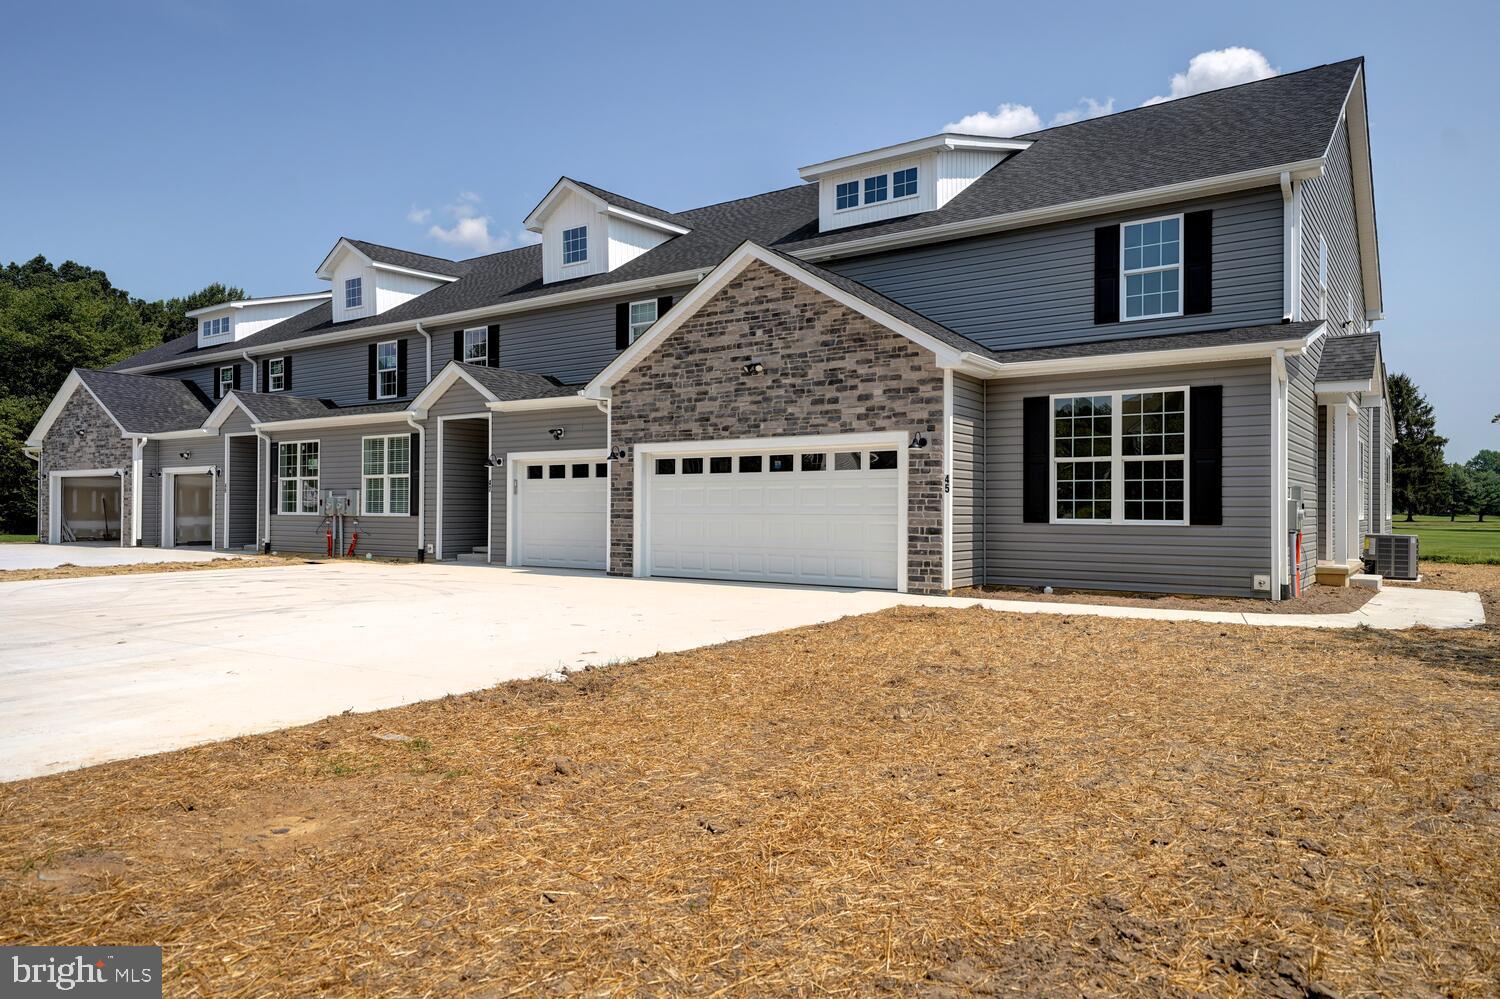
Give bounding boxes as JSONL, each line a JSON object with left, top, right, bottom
{"left": 522, "top": 177, "right": 689, "bottom": 284}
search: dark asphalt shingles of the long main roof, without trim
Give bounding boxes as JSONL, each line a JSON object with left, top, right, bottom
{"left": 116, "top": 59, "right": 1364, "bottom": 368}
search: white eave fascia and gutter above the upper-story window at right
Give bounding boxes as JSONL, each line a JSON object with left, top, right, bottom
{"left": 789, "top": 158, "right": 1323, "bottom": 260}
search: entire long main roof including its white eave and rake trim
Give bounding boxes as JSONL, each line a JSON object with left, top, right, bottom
{"left": 105, "top": 59, "right": 1379, "bottom": 378}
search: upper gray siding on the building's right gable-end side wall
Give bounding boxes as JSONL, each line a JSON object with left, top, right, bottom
{"left": 1298, "top": 122, "right": 1365, "bottom": 322}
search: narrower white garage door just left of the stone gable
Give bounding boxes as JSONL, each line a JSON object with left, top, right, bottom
{"left": 516, "top": 459, "right": 609, "bottom": 569}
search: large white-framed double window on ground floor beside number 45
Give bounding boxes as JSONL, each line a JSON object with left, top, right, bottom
{"left": 1052, "top": 389, "right": 1188, "bottom": 525}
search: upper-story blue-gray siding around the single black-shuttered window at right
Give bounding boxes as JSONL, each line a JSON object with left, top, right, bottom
{"left": 827, "top": 189, "right": 1283, "bottom": 350}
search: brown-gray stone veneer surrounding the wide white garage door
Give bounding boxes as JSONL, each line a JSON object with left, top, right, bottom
{"left": 609, "top": 263, "right": 944, "bottom": 593}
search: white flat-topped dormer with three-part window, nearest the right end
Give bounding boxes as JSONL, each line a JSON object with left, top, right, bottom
{"left": 798, "top": 132, "right": 1031, "bottom": 233}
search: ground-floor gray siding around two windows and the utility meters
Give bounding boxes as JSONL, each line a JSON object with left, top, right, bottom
{"left": 261, "top": 420, "right": 417, "bottom": 558}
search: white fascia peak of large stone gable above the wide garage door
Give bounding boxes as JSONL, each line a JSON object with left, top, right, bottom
{"left": 582, "top": 240, "right": 962, "bottom": 399}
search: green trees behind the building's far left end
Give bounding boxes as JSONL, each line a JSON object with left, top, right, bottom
{"left": 0, "top": 257, "right": 245, "bottom": 534}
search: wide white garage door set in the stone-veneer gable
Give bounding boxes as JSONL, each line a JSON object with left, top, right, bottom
{"left": 645, "top": 449, "right": 902, "bottom": 588}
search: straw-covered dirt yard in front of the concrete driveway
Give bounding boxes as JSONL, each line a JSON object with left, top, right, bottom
{"left": 0, "top": 566, "right": 1500, "bottom": 998}
